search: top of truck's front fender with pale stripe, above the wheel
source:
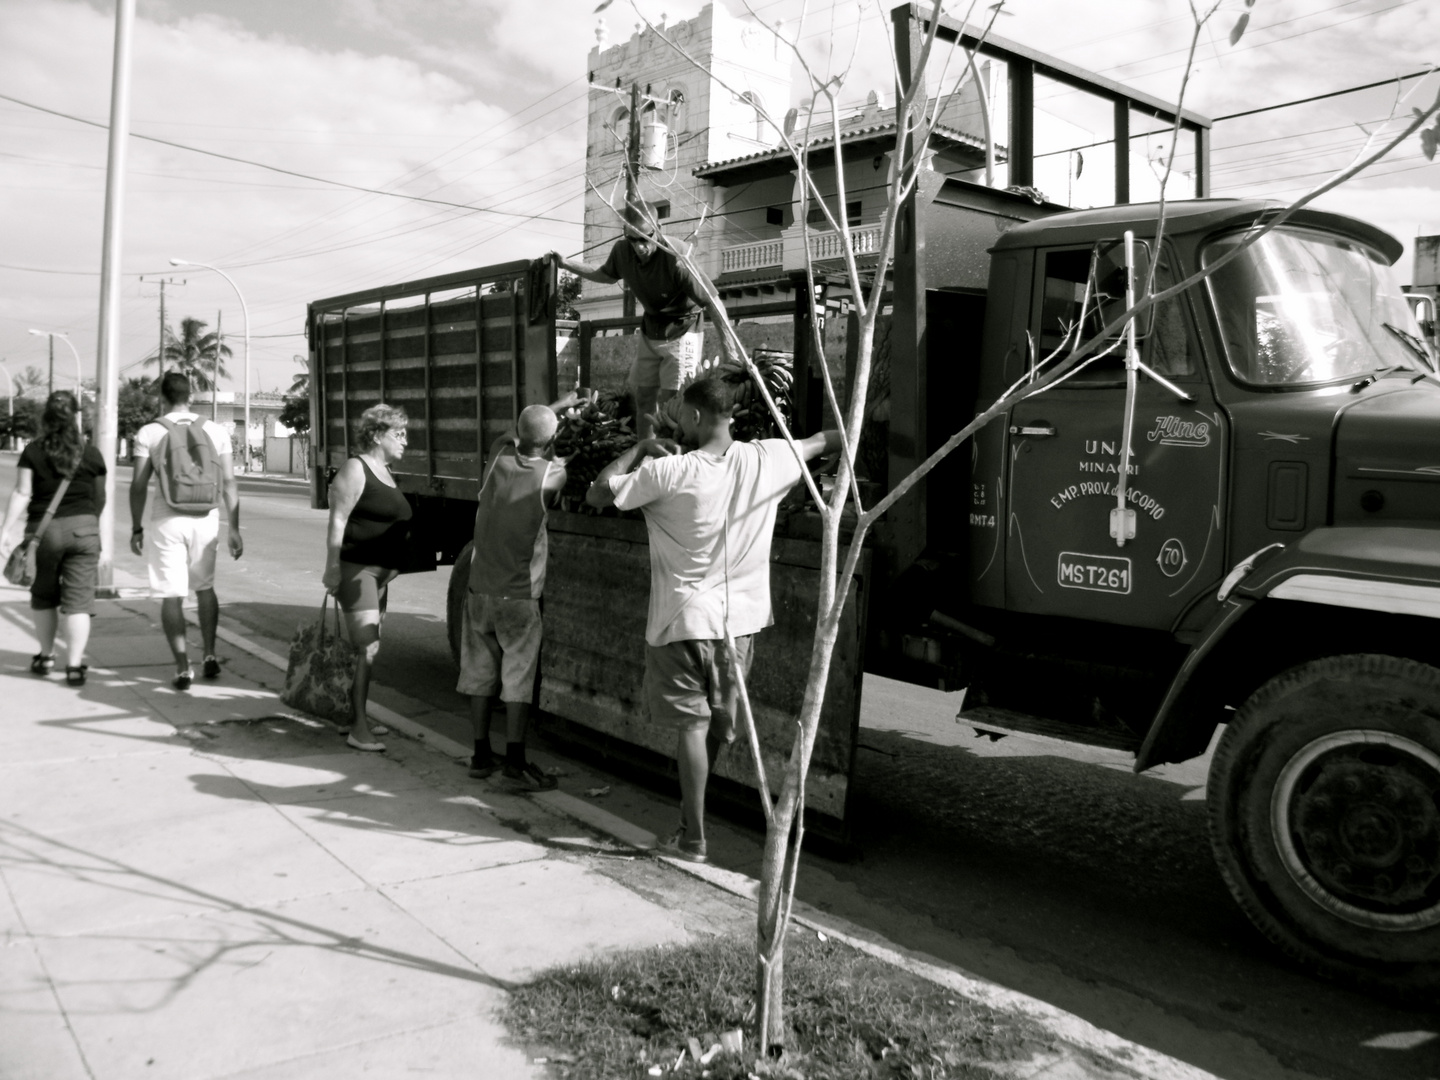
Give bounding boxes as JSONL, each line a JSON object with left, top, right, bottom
{"left": 1236, "top": 526, "right": 1440, "bottom": 619}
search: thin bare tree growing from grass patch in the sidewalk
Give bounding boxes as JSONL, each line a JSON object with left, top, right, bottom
{"left": 592, "top": 0, "right": 1440, "bottom": 1054}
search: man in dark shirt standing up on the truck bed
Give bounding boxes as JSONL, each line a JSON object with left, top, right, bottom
{"left": 547, "top": 215, "right": 732, "bottom": 439}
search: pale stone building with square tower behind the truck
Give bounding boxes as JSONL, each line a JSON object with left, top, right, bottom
{"left": 576, "top": 0, "right": 1197, "bottom": 318}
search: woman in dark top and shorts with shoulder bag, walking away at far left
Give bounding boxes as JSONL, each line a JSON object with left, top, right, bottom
{"left": 0, "top": 390, "right": 105, "bottom": 687}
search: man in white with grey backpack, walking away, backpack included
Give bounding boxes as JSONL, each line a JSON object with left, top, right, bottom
{"left": 130, "top": 372, "right": 245, "bottom": 690}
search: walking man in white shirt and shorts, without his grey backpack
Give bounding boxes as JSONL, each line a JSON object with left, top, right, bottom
{"left": 130, "top": 372, "right": 245, "bottom": 690}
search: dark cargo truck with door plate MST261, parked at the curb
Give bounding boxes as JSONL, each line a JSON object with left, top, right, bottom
{"left": 307, "top": 179, "right": 1440, "bottom": 992}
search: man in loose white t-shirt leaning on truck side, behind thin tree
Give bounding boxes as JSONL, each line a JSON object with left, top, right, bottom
{"left": 586, "top": 377, "right": 840, "bottom": 863}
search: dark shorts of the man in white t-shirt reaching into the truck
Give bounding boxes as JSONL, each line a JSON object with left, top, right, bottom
{"left": 645, "top": 634, "right": 755, "bottom": 743}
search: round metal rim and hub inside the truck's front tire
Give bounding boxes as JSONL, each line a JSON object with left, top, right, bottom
{"left": 1272, "top": 730, "right": 1440, "bottom": 930}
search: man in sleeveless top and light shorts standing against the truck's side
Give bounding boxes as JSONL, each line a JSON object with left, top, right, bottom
{"left": 456, "top": 393, "right": 576, "bottom": 791}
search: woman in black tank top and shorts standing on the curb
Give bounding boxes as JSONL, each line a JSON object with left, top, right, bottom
{"left": 320, "top": 405, "right": 412, "bottom": 750}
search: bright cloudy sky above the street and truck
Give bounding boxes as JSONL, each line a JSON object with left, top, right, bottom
{"left": 0, "top": 0, "right": 1440, "bottom": 389}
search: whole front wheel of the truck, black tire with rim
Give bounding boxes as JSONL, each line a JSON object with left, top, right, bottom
{"left": 1208, "top": 654, "right": 1440, "bottom": 995}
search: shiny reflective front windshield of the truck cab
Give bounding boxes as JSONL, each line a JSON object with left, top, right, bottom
{"left": 1204, "top": 228, "right": 1428, "bottom": 386}
